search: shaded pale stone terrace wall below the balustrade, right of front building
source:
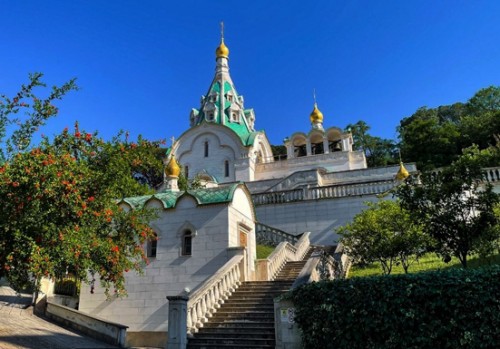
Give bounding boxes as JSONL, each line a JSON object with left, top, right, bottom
{"left": 255, "top": 195, "right": 380, "bottom": 245}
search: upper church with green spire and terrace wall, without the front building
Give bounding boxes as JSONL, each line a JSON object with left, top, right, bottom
{"left": 167, "top": 30, "right": 416, "bottom": 245}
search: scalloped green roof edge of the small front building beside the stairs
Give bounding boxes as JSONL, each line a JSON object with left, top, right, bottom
{"left": 120, "top": 183, "right": 241, "bottom": 209}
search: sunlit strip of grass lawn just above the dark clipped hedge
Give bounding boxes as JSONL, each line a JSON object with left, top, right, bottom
{"left": 349, "top": 253, "right": 500, "bottom": 278}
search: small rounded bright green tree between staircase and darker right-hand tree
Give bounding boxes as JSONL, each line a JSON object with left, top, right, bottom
{"left": 338, "top": 200, "right": 427, "bottom": 274}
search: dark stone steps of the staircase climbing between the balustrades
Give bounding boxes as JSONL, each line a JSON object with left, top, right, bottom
{"left": 187, "top": 251, "right": 312, "bottom": 349}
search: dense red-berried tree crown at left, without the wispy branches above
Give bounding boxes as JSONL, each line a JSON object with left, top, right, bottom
{"left": 0, "top": 125, "right": 160, "bottom": 293}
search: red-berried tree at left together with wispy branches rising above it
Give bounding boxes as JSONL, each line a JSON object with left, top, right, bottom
{"left": 0, "top": 75, "right": 162, "bottom": 294}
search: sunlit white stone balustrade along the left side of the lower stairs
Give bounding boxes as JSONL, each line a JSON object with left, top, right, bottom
{"left": 187, "top": 255, "right": 243, "bottom": 335}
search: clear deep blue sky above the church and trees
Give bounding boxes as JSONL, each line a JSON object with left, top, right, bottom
{"left": 0, "top": 0, "right": 500, "bottom": 144}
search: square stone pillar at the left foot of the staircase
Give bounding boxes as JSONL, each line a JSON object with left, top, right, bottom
{"left": 166, "top": 296, "right": 189, "bottom": 349}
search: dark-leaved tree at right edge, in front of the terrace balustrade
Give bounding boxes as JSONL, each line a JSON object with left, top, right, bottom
{"left": 396, "top": 147, "right": 500, "bottom": 268}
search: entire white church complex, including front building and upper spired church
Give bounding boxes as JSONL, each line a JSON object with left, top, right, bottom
{"left": 79, "top": 29, "right": 416, "bottom": 346}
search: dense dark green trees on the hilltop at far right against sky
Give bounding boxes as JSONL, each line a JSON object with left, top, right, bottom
{"left": 398, "top": 86, "right": 500, "bottom": 170}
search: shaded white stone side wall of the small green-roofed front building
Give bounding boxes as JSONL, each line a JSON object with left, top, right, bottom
{"left": 79, "top": 196, "right": 236, "bottom": 331}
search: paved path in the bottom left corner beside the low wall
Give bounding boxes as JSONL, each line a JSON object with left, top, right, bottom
{"left": 0, "top": 286, "right": 117, "bottom": 349}
